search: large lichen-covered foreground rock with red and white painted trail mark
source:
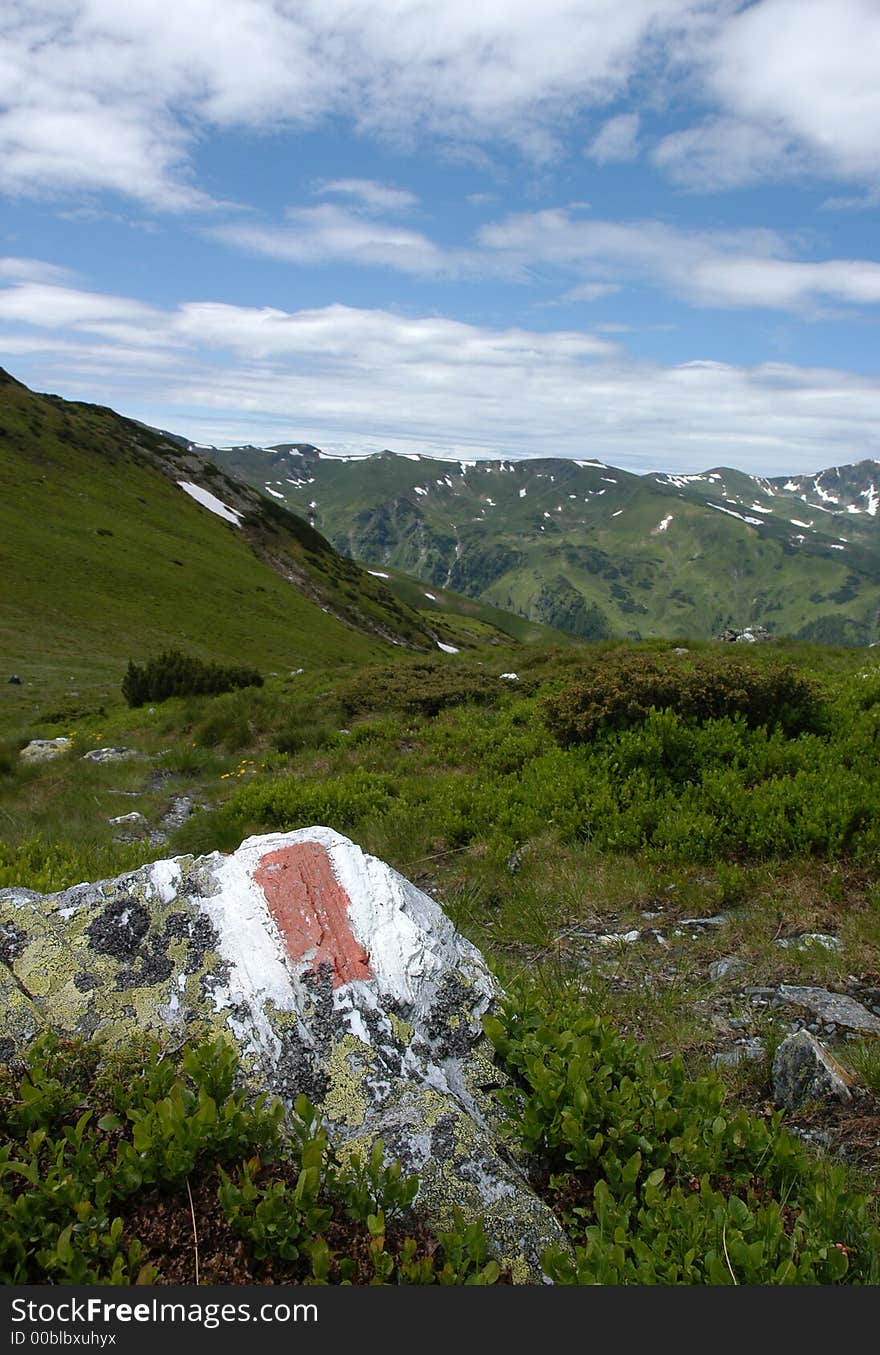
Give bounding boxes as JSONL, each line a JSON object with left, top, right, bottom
{"left": 0, "top": 828, "right": 565, "bottom": 1282}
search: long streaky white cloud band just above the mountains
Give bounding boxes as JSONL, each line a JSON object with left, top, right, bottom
{"left": 6, "top": 275, "right": 880, "bottom": 474}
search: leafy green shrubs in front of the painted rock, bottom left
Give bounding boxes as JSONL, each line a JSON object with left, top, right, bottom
{"left": 0, "top": 1035, "right": 499, "bottom": 1285}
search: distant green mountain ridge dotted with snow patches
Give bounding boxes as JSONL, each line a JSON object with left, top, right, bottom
{"left": 199, "top": 443, "right": 880, "bottom": 645}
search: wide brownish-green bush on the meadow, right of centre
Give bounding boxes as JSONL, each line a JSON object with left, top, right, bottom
{"left": 545, "top": 652, "right": 822, "bottom": 744}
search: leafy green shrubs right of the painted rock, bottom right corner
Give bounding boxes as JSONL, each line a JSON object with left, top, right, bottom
{"left": 485, "top": 1001, "right": 880, "bottom": 1285}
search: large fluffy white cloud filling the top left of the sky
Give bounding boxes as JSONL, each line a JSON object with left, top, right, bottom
{"left": 0, "top": 0, "right": 705, "bottom": 210}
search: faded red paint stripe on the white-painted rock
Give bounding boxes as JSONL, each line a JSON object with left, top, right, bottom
{"left": 254, "top": 843, "right": 373, "bottom": 988}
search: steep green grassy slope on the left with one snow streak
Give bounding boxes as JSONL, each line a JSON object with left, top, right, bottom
{"left": 0, "top": 371, "right": 466, "bottom": 703}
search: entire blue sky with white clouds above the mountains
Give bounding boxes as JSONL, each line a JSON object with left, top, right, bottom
{"left": 0, "top": 0, "right": 880, "bottom": 476}
